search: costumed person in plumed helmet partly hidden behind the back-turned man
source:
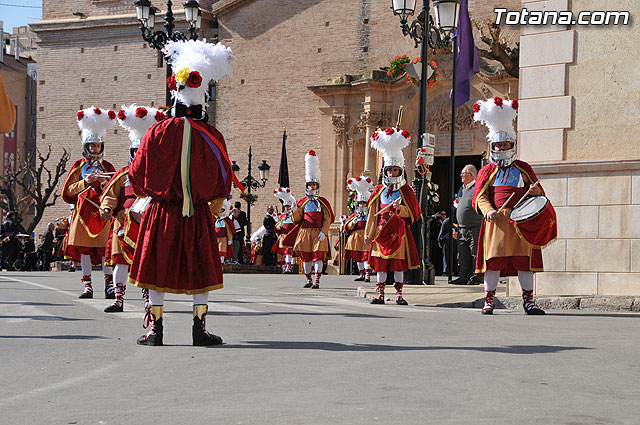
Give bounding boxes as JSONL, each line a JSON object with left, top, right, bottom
{"left": 100, "top": 105, "right": 165, "bottom": 313}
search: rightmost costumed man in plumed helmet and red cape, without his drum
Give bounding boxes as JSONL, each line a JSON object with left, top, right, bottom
{"left": 473, "top": 97, "right": 544, "bottom": 315}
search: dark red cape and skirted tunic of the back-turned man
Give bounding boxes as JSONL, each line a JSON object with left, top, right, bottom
{"left": 129, "top": 117, "right": 231, "bottom": 294}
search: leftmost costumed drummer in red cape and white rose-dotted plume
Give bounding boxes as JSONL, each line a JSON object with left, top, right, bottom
{"left": 62, "top": 107, "right": 116, "bottom": 299}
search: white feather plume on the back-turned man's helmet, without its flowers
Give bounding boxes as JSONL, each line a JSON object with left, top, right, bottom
{"left": 164, "top": 40, "right": 233, "bottom": 106}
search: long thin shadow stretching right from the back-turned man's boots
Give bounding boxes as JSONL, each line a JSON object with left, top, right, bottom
{"left": 225, "top": 341, "right": 590, "bottom": 354}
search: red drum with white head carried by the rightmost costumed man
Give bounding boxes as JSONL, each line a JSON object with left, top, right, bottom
{"left": 509, "top": 196, "right": 558, "bottom": 248}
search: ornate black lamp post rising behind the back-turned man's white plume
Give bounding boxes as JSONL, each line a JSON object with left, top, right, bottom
{"left": 134, "top": 0, "right": 202, "bottom": 106}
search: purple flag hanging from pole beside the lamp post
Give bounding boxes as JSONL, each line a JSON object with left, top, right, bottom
{"left": 453, "top": 0, "right": 480, "bottom": 108}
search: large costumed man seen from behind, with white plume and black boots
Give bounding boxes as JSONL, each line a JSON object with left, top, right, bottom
{"left": 129, "top": 40, "right": 244, "bottom": 346}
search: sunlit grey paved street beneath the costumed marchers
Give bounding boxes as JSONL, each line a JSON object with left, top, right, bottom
{"left": 0, "top": 272, "right": 640, "bottom": 425}
